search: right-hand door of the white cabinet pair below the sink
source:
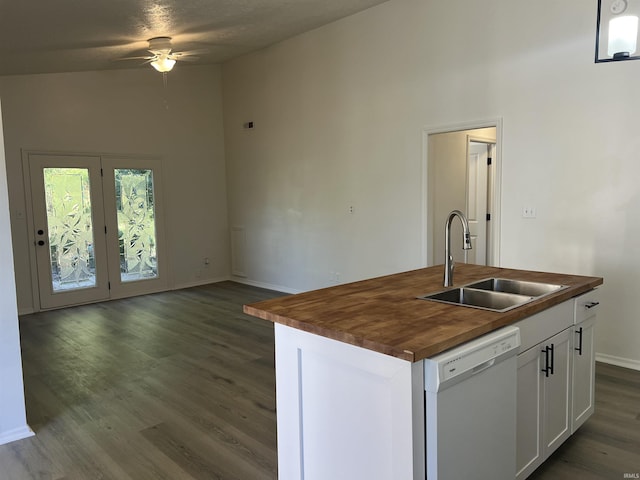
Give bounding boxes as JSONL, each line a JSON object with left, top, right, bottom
{"left": 540, "top": 328, "right": 573, "bottom": 457}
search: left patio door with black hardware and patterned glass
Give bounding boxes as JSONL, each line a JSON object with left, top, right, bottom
{"left": 29, "top": 154, "right": 109, "bottom": 308}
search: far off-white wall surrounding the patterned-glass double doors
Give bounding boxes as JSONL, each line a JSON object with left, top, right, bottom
{"left": 0, "top": 66, "right": 229, "bottom": 312}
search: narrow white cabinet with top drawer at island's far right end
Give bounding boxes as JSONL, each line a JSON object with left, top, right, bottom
{"left": 571, "top": 290, "right": 599, "bottom": 433}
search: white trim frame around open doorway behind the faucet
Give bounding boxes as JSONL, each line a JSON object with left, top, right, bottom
{"left": 421, "top": 117, "right": 503, "bottom": 267}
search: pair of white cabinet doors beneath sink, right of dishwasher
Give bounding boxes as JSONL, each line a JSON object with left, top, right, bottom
{"left": 516, "top": 328, "right": 572, "bottom": 479}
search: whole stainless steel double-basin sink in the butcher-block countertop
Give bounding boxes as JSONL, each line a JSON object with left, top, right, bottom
{"left": 418, "top": 278, "right": 568, "bottom": 312}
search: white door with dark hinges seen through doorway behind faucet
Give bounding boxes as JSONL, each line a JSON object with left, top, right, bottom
{"left": 466, "top": 140, "right": 489, "bottom": 265}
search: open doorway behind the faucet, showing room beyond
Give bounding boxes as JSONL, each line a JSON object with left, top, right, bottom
{"left": 424, "top": 121, "right": 500, "bottom": 266}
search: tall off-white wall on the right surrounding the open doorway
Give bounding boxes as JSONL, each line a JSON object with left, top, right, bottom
{"left": 223, "top": 0, "right": 640, "bottom": 367}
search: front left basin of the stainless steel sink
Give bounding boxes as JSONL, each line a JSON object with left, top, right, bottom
{"left": 418, "top": 287, "right": 535, "bottom": 312}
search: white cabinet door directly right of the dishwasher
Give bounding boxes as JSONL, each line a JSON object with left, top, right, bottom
{"left": 516, "top": 345, "right": 543, "bottom": 480}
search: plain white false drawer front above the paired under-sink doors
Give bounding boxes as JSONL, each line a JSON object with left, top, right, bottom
{"left": 513, "top": 300, "right": 574, "bottom": 352}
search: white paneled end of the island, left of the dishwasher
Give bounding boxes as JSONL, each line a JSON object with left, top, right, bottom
{"left": 275, "top": 324, "right": 425, "bottom": 480}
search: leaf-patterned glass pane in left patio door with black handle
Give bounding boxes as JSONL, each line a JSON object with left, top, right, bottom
{"left": 44, "top": 168, "right": 96, "bottom": 292}
